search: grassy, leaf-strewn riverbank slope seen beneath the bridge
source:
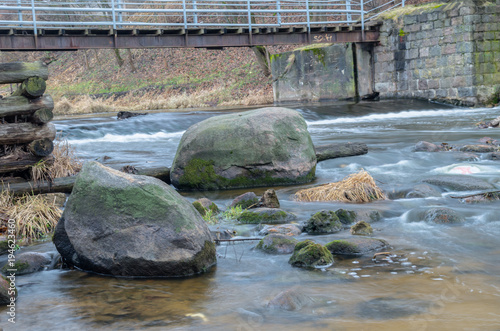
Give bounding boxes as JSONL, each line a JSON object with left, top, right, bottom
{"left": 0, "top": 46, "right": 294, "bottom": 116}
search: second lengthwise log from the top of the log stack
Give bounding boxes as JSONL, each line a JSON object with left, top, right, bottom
{"left": 0, "top": 95, "right": 54, "bottom": 117}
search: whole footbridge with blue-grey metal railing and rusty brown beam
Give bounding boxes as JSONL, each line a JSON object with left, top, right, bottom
{"left": 0, "top": 0, "right": 404, "bottom": 51}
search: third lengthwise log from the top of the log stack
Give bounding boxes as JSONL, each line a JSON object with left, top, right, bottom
{"left": 0, "top": 123, "right": 56, "bottom": 145}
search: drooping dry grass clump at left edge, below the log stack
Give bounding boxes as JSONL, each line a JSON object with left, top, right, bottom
{"left": 0, "top": 189, "right": 62, "bottom": 243}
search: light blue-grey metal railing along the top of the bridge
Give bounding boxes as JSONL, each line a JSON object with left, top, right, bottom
{"left": 0, "top": 0, "right": 404, "bottom": 35}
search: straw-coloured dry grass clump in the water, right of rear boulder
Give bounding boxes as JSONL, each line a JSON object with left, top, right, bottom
{"left": 295, "top": 170, "right": 387, "bottom": 203}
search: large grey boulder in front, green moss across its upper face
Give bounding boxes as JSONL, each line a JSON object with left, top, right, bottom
{"left": 53, "top": 162, "right": 216, "bottom": 277}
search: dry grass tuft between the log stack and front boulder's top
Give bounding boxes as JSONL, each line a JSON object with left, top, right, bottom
{"left": 31, "top": 137, "right": 82, "bottom": 183}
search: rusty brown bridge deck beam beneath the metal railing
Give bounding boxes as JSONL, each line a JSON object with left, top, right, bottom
{"left": 0, "top": 25, "right": 379, "bottom": 51}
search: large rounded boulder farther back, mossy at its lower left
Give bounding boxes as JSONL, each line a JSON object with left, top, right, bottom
{"left": 170, "top": 107, "right": 316, "bottom": 190}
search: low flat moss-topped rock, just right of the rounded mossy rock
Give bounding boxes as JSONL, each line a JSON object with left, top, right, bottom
{"left": 325, "top": 237, "right": 389, "bottom": 256}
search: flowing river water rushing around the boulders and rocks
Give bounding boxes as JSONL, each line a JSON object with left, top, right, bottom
{"left": 0, "top": 100, "right": 500, "bottom": 330}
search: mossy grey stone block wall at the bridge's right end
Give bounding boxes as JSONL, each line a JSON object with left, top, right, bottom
{"left": 374, "top": 0, "right": 500, "bottom": 106}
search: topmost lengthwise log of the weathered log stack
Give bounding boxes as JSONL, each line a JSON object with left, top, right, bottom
{"left": 0, "top": 62, "right": 49, "bottom": 84}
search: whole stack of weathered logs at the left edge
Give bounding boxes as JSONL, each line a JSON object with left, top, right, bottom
{"left": 0, "top": 62, "right": 56, "bottom": 177}
